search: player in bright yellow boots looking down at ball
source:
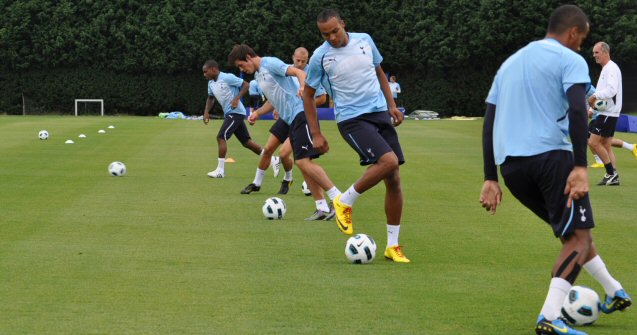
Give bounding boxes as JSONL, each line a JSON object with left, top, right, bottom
{"left": 303, "top": 9, "right": 409, "bottom": 263}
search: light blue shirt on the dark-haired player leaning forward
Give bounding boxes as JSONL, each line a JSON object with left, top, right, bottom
{"left": 254, "top": 57, "right": 303, "bottom": 125}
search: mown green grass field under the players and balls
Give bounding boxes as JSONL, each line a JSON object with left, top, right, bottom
{"left": 0, "top": 116, "right": 637, "bottom": 335}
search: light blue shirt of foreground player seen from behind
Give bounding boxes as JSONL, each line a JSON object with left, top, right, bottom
{"left": 486, "top": 38, "right": 591, "bottom": 165}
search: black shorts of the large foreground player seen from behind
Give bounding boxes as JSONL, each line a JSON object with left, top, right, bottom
{"left": 500, "top": 150, "right": 595, "bottom": 237}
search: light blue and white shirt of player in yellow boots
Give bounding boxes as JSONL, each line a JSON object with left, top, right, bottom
{"left": 305, "top": 33, "right": 387, "bottom": 122}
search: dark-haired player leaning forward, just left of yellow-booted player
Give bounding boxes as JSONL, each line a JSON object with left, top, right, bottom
{"left": 228, "top": 44, "right": 341, "bottom": 220}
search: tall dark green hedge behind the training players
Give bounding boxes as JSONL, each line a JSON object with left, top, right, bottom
{"left": 0, "top": 0, "right": 637, "bottom": 116}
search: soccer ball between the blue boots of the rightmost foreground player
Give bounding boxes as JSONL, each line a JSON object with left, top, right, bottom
{"left": 562, "top": 286, "right": 599, "bottom": 326}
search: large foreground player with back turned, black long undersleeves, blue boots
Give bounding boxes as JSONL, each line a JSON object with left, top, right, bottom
{"left": 480, "top": 5, "right": 632, "bottom": 335}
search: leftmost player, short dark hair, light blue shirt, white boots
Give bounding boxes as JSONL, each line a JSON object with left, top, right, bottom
{"left": 203, "top": 59, "right": 274, "bottom": 178}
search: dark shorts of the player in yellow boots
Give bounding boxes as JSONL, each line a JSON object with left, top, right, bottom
{"left": 338, "top": 112, "right": 405, "bottom": 165}
